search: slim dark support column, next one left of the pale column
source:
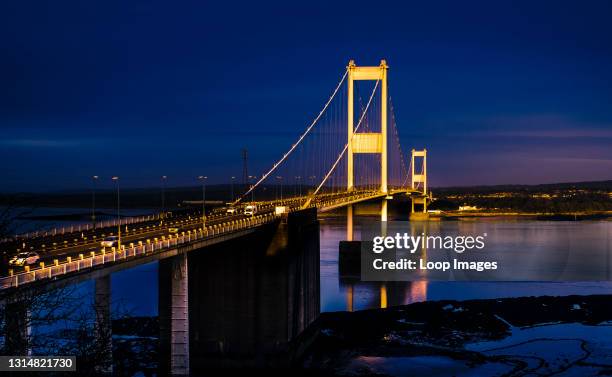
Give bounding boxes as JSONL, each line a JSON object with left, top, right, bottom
{"left": 94, "top": 275, "right": 113, "bottom": 374}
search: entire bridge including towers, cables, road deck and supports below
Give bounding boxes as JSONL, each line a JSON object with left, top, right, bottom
{"left": 0, "top": 60, "right": 431, "bottom": 375}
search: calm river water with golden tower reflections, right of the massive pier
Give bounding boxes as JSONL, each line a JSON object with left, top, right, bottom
{"left": 320, "top": 210, "right": 612, "bottom": 312}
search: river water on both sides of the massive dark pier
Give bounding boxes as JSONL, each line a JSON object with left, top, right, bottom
{"left": 105, "top": 212, "right": 612, "bottom": 315}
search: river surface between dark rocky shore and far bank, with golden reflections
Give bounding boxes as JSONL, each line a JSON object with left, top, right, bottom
{"left": 321, "top": 217, "right": 612, "bottom": 312}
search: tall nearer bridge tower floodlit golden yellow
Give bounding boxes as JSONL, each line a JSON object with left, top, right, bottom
{"left": 346, "top": 59, "right": 389, "bottom": 221}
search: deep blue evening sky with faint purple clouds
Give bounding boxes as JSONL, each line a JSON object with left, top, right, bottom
{"left": 0, "top": 0, "right": 612, "bottom": 191}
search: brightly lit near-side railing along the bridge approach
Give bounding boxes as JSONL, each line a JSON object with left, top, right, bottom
{"left": 0, "top": 213, "right": 279, "bottom": 289}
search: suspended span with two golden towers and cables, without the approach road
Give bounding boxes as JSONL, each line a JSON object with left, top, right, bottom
{"left": 235, "top": 60, "right": 428, "bottom": 217}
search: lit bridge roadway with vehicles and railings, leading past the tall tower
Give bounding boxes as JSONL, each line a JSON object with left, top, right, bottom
{"left": 0, "top": 190, "right": 407, "bottom": 290}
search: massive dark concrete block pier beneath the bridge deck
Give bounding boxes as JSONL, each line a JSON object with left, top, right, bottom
{"left": 189, "top": 209, "right": 320, "bottom": 368}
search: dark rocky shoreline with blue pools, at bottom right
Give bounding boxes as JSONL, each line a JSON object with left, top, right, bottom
{"left": 295, "top": 295, "right": 612, "bottom": 376}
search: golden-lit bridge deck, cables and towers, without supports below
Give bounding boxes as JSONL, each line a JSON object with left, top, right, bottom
{"left": 0, "top": 60, "right": 430, "bottom": 289}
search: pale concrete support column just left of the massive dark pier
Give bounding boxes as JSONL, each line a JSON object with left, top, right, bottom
{"left": 159, "top": 254, "right": 189, "bottom": 376}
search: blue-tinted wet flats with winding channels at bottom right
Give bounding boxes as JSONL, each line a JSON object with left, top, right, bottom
{"left": 341, "top": 318, "right": 612, "bottom": 377}
